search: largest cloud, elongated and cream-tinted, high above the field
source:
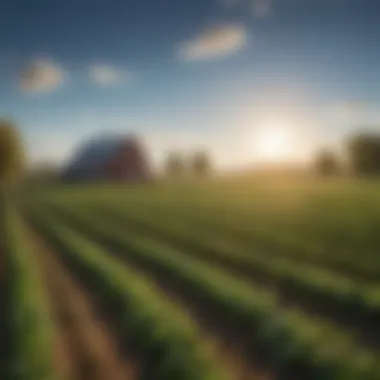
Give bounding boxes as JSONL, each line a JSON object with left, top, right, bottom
{"left": 180, "top": 24, "right": 247, "bottom": 61}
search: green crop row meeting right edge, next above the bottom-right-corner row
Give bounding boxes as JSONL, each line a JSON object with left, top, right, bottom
{"left": 93, "top": 203, "right": 380, "bottom": 331}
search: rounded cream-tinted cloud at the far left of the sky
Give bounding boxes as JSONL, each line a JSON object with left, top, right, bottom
{"left": 19, "top": 59, "right": 64, "bottom": 93}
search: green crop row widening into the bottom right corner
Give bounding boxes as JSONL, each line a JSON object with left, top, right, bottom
{"left": 37, "top": 205, "right": 380, "bottom": 380}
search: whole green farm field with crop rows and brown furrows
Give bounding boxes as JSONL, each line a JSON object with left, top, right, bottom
{"left": 1, "top": 179, "right": 380, "bottom": 380}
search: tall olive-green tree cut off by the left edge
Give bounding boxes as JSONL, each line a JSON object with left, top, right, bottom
{"left": 0, "top": 120, "right": 25, "bottom": 186}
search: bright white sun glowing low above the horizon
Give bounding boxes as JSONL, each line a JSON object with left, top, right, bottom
{"left": 255, "top": 127, "right": 291, "bottom": 161}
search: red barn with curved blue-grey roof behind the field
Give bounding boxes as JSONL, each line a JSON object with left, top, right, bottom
{"left": 62, "top": 136, "right": 152, "bottom": 182}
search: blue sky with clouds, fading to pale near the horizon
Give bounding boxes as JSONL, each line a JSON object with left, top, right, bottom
{"left": 0, "top": 0, "right": 380, "bottom": 166}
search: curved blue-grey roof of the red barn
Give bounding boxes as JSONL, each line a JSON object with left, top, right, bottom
{"left": 65, "top": 135, "right": 141, "bottom": 174}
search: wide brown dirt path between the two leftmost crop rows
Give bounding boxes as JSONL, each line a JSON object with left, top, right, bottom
{"left": 30, "top": 229, "right": 138, "bottom": 380}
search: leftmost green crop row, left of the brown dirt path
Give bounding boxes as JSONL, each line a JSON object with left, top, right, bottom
{"left": 1, "top": 208, "right": 56, "bottom": 380}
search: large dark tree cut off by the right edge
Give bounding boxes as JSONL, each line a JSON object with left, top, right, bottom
{"left": 347, "top": 133, "right": 380, "bottom": 176}
